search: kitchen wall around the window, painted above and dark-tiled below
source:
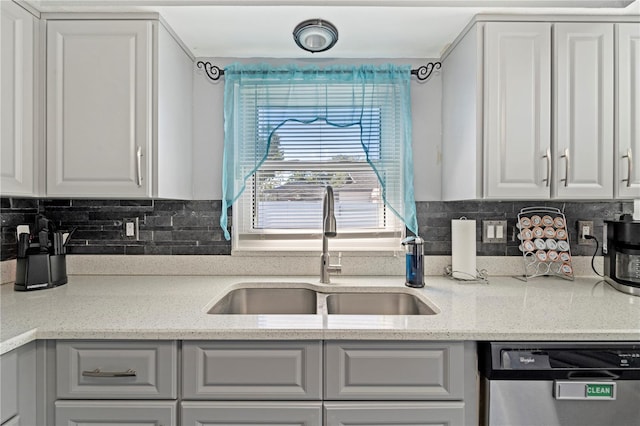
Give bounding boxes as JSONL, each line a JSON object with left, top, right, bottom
{"left": 0, "top": 58, "right": 632, "bottom": 260}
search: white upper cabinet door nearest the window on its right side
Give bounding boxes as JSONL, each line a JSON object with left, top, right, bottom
{"left": 484, "top": 22, "right": 551, "bottom": 199}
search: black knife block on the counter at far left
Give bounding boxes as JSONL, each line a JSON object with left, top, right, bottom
{"left": 13, "top": 215, "right": 71, "bottom": 291}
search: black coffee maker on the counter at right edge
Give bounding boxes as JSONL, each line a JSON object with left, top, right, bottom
{"left": 603, "top": 214, "right": 640, "bottom": 296}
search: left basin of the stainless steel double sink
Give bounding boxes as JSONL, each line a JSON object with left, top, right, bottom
{"left": 208, "top": 288, "right": 318, "bottom": 315}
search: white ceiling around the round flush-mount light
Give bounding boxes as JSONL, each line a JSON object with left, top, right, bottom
{"left": 19, "top": 0, "right": 640, "bottom": 58}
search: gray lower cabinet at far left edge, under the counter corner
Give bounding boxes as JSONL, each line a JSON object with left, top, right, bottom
{"left": 0, "top": 342, "right": 36, "bottom": 426}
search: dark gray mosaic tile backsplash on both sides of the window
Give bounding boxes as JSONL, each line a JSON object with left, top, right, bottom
{"left": 0, "top": 198, "right": 633, "bottom": 260}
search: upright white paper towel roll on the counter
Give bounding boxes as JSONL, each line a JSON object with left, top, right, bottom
{"left": 451, "top": 219, "right": 476, "bottom": 280}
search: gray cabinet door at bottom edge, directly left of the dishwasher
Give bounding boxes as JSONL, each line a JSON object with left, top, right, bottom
{"left": 324, "top": 402, "right": 464, "bottom": 426}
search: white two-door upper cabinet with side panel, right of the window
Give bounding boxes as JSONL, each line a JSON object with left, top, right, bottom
{"left": 442, "top": 22, "right": 616, "bottom": 200}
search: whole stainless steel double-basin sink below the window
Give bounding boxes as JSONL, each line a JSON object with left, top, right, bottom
{"left": 207, "top": 283, "right": 439, "bottom": 315}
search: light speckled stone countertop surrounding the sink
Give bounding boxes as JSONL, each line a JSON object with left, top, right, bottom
{"left": 0, "top": 275, "right": 640, "bottom": 353}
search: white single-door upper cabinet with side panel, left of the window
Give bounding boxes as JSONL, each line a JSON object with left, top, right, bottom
{"left": 47, "top": 20, "right": 192, "bottom": 199}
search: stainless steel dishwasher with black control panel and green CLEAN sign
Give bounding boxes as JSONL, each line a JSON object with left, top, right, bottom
{"left": 478, "top": 342, "right": 640, "bottom": 426}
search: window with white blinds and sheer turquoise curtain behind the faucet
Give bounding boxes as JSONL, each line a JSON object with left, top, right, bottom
{"left": 221, "top": 62, "right": 415, "bottom": 251}
